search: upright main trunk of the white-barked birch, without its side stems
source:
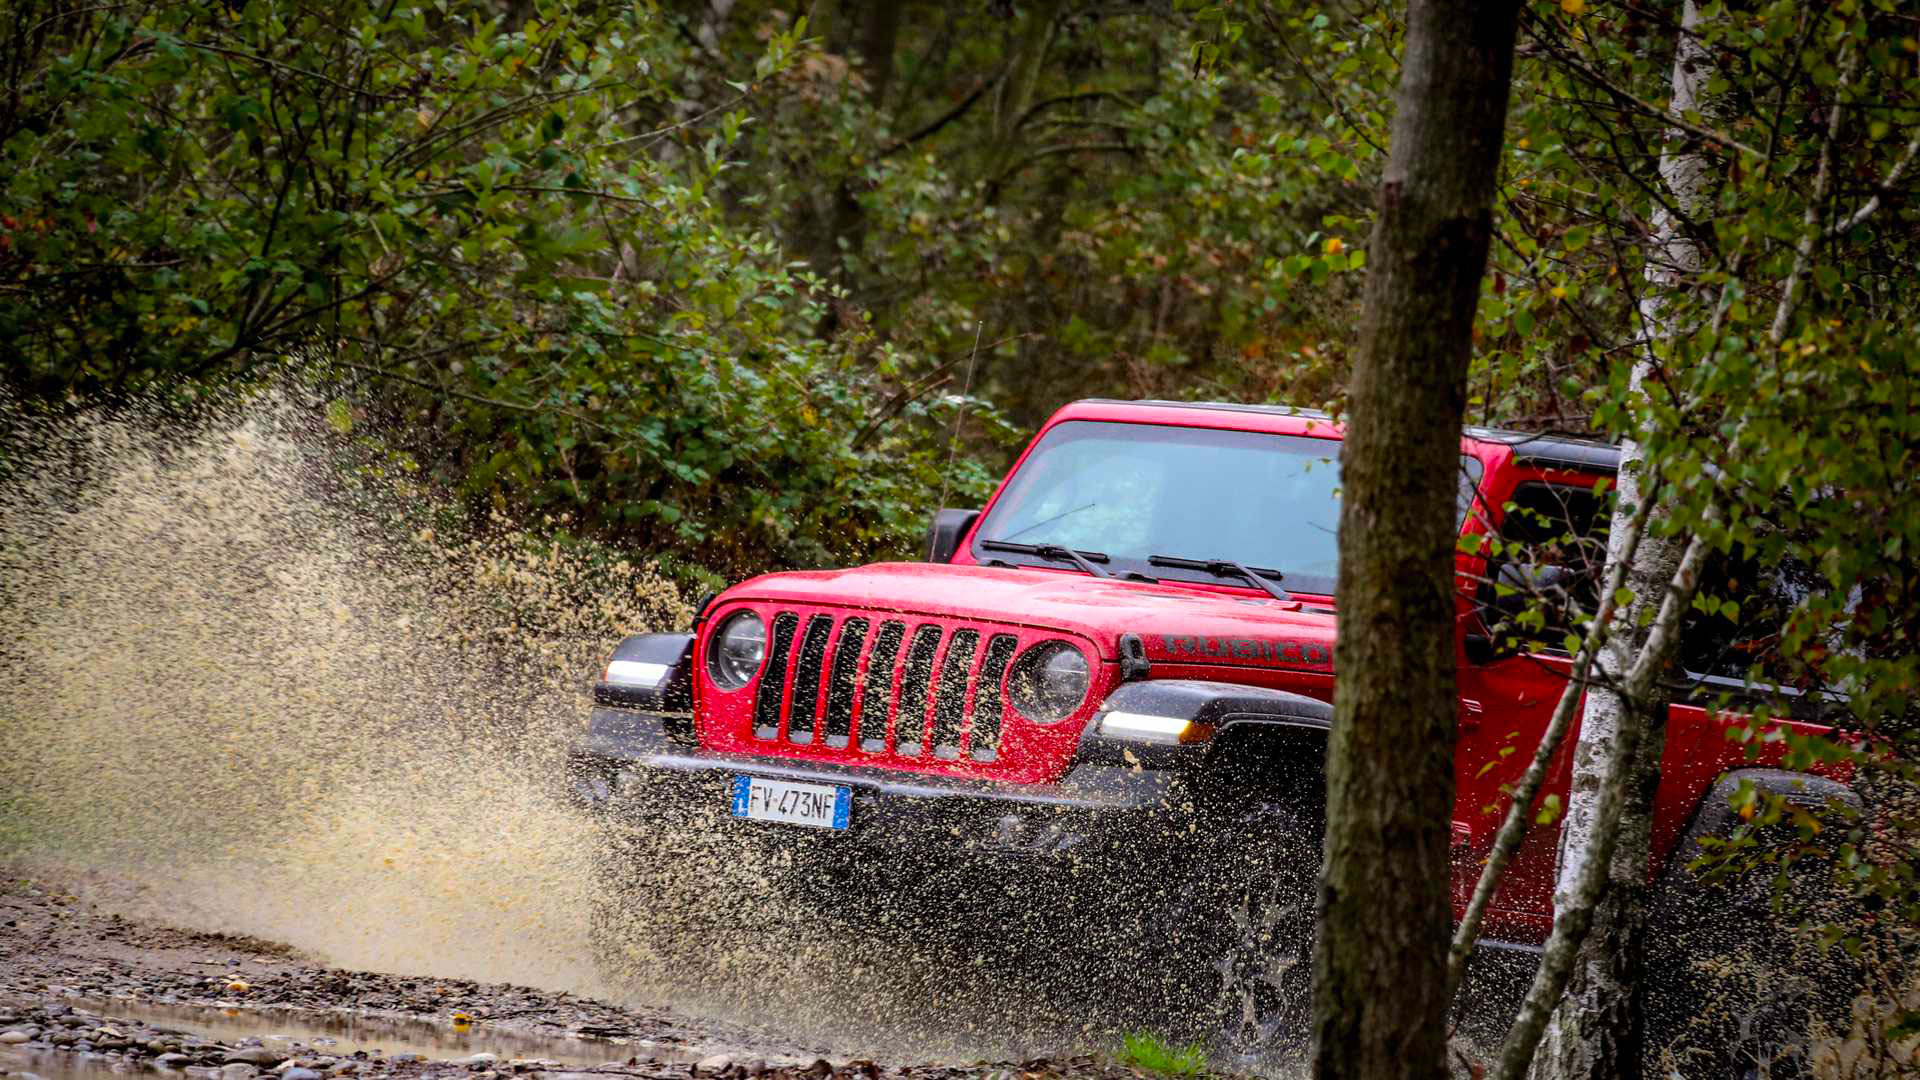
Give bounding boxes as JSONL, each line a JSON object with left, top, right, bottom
{"left": 1534, "top": 0, "right": 1716, "bottom": 1080}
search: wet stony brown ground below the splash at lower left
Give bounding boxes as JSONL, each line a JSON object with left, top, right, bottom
{"left": 0, "top": 871, "right": 1133, "bottom": 1080}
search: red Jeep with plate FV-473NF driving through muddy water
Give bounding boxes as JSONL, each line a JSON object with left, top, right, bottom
{"left": 574, "top": 400, "right": 1843, "bottom": 1047}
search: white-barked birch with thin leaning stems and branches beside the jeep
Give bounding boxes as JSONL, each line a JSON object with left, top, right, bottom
{"left": 1450, "top": 10, "right": 1896, "bottom": 1080}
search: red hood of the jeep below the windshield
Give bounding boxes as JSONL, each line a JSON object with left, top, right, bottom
{"left": 722, "top": 563, "right": 1334, "bottom": 671}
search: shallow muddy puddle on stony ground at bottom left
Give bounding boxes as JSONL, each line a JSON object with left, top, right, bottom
{"left": 0, "top": 999, "right": 668, "bottom": 1080}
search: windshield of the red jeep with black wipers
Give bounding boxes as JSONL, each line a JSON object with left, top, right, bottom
{"left": 973, "top": 421, "right": 1340, "bottom": 594}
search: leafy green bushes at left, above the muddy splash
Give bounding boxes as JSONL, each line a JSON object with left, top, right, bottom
{"left": 0, "top": 0, "right": 1002, "bottom": 569}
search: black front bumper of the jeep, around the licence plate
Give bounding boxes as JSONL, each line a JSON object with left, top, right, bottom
{"left": 570, "top": 705, "right": 1190, "bottom": 865}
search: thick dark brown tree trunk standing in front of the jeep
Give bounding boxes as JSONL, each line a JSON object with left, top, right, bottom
{"left": 1313, "top": 0, "right": 1517, "bottom": 1080}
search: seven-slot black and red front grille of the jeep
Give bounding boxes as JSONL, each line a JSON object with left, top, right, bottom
{"left": 753, "top": 611, "right": 1020, "bottom": 761}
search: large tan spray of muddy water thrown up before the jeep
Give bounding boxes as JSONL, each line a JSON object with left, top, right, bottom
{"left": 0, "top": 394, "right": 1102, "bottom": 1057}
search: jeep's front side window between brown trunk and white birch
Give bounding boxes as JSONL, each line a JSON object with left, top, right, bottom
{"left": 1478, "top": 477, "right": 1613, "bottom": 651}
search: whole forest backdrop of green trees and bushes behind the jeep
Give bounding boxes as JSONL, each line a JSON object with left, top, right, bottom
{"left": 0, "top": 0, "right": 1920, "bottom": 1068}
